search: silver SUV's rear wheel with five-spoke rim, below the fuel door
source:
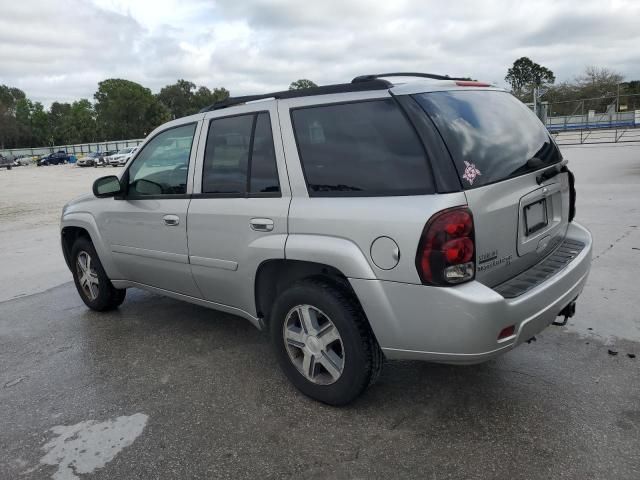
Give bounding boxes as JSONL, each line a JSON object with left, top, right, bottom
{"left": 270, "top": 279, "right": 383, "bottom": 405}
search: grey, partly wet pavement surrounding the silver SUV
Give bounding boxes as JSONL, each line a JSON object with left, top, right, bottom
{"left": 0, "top": 146, "right": 640, "bottom": 480}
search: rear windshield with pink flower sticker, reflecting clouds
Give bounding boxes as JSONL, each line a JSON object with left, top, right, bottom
{"left": 415, "top": 90, "right": 562, "bottom": 189}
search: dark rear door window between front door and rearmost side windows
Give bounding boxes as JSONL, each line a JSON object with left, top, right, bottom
{"left": 202, "top": 112, "right": 280, "bottom": 195}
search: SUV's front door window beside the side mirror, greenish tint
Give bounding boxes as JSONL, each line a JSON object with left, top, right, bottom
{"left": 128, "top": 123, "right": 196, "bottom": 197}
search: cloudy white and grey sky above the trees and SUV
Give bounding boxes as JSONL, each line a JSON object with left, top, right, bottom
{"left": 0, "top": 0, "right": 640, "bottom": 105}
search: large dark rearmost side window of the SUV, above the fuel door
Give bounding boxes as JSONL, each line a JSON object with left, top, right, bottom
{"left": 291, "top": 99, "right": 434, "bottom": 197}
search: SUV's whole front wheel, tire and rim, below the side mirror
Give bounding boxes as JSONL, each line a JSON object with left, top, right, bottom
{"left": 71, "top": 237, "right": 127, "bottom": 311}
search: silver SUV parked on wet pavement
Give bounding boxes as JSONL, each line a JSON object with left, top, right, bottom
{"left": 61, "top": 74, "right": 592, "bottom": 405}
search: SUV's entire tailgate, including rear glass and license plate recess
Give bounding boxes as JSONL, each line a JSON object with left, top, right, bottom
{"left": 414, "top": 88, "right": 570, "bottom": 286}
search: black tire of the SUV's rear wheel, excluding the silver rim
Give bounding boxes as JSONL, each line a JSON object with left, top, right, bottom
{"left": 269, "top": 279, "right": 384, "bottom": 405}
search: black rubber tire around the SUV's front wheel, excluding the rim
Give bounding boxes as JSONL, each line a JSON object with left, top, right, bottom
{"left": 71, "top": 237, "right": 127, "bottom": 312}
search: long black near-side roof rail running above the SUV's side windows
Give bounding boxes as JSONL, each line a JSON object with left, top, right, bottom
{"left": 199, "top": 78, "right": 392, "bottom": 113}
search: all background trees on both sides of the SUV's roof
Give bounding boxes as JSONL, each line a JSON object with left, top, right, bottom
{"left": 0, "top": 61, "right": 640, "bottom": 149}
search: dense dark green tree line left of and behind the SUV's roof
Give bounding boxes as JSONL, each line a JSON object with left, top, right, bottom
{"left": 0, "top": 78, "right": 315, "bottom": 149}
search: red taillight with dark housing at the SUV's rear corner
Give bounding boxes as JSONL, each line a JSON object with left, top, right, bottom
{"left": 416, "top": 207, "right": 476, "bottom": 285}
